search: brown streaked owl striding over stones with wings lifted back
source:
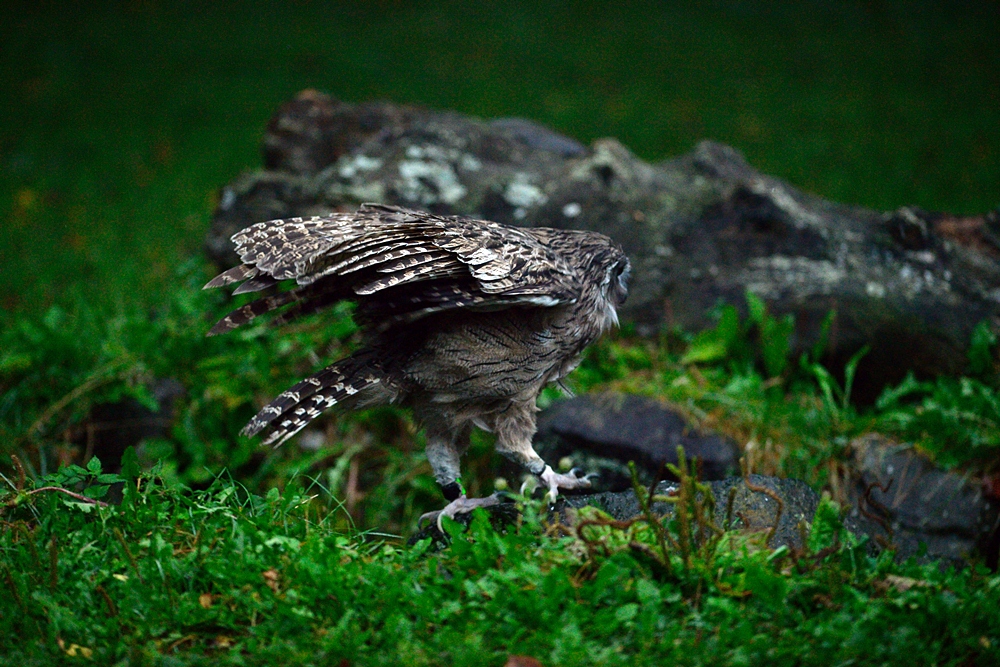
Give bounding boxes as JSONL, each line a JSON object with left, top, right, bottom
{"left": 205, "top": 204, "right": 630, "bottom": 527}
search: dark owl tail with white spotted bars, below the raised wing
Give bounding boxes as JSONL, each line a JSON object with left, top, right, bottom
{"left": 241, "top": 351, "right": 397, "bottom": 447}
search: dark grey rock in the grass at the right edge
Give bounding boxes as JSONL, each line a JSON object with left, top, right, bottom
{"left": 848, "top": 434, "right": 1000, "bottom": 563}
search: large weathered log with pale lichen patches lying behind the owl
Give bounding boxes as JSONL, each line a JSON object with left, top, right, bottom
{"left": 207, "top": 91, "right": 1000, "bottom": 400}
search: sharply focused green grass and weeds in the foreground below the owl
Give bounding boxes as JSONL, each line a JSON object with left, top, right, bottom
{"left": 0, "top": 465, "right": 1000, "bottom": 665}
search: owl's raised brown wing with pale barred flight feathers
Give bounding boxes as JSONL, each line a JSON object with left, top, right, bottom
{"left": 205, "top": 204, "right": 580, "bottom": 335}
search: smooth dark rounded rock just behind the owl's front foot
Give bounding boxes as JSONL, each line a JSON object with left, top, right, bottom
{"left": 535, "top": 393, "right": 739, "bottom": 491}
